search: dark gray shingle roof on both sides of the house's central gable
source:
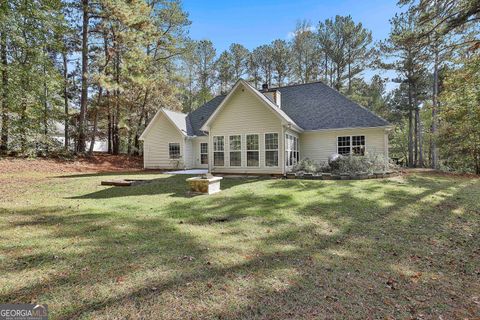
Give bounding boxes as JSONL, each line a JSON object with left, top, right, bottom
{"left": 186, "top": 82, "right": 389, "bottom": 136}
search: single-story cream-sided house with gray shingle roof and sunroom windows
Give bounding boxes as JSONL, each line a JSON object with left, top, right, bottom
{"left": 140, "top": 79, "right": 391, "bottom": 174}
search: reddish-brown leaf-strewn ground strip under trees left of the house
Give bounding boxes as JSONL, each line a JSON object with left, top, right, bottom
{"left": 0, "top": 154, "right": 142, "bottom": 173}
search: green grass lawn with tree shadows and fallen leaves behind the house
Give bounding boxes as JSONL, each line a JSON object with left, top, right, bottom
{"left": 0, "top": 172, "right": 480, "bottom": 319}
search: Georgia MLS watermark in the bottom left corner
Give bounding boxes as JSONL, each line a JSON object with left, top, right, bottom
{"left": 0, "top": 303, "right": 48, "bottom": 320}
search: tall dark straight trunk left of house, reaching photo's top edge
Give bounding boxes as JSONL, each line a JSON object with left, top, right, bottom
{"left": 77, "top": 0, "right": 89, "bottom": 152}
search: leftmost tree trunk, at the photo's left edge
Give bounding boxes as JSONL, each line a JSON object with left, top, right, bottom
{"left": 0, "top": 26, "right": 10, "bottom": 154}
